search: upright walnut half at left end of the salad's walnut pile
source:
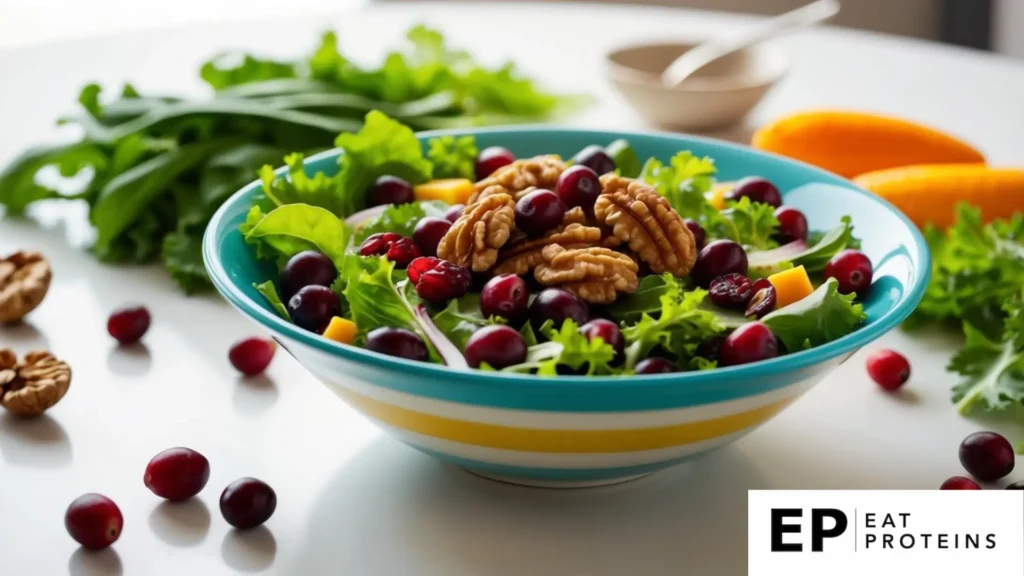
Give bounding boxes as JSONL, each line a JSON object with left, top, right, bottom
{"left": 437, "top": 194, "right": 515, "bottom": 272}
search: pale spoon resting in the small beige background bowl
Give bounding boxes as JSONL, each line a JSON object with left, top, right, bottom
{"left": 662, "top": 0, "right": 840, "bottom": 87}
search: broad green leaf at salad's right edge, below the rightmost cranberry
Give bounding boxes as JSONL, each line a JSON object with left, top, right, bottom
{"left": 761, "top": 278, "right": 867, "bottom": 352}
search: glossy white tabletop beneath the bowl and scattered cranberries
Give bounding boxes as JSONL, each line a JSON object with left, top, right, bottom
{"left": 0, "top": 3, "right": 1024, "bottom": 576}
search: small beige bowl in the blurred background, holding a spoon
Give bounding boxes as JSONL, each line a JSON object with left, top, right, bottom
{"left": 605, "top": 42, "right": 788, "bottom": 129}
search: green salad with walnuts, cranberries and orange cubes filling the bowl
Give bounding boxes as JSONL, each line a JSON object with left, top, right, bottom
{"left": 241, "top": 111, "right": 872, "bottom": 376}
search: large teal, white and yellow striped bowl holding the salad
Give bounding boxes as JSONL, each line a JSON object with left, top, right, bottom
{"left": 203, "top": 127, "right": 931, "bottom": 487}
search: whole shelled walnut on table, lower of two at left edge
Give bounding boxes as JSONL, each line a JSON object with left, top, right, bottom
{"left": 0, "top": 348, "right": 71, "bottom": 416}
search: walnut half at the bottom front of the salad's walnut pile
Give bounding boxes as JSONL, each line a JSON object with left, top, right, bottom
{"left": 534, "top": 244, "right": 640, "bottom": 304}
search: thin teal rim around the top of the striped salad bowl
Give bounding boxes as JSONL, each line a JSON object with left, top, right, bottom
{"left": 203, "top": 124, "right": 932, "bottom": 386}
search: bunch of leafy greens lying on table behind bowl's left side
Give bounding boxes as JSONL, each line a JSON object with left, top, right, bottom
{"left": 0, "top": 27, "right": 584, "bottom": 293}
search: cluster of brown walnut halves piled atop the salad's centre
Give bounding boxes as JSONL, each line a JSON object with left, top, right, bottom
{"left": 437, "top": 156, "right": 697, "bottom": 304}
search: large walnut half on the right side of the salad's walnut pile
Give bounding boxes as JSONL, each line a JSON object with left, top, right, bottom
{"left": 594, "top": 174, "right": 697, "bottom": 276}
